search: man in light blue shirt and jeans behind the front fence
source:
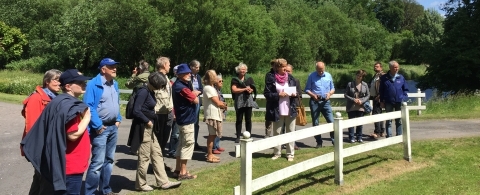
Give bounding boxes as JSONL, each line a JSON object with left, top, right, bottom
{"left": 305, "top": 61, "right": 335, "bottom": 148}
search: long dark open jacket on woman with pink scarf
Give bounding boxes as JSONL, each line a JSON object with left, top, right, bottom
{"left": 263, "top": 74, "right": 298, "bottom": 122}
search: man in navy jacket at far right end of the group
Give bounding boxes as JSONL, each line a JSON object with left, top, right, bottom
{"left": 379, "top": 61, "right": 408, "bottom": 138}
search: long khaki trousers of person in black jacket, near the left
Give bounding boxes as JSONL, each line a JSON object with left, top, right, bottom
{"left": 135, "top": 127, "right": 169, "bottom": 188}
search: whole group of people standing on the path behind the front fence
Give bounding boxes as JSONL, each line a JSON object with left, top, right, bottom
{"left": 21, "top": 57, "right": 408, "bottom": 195}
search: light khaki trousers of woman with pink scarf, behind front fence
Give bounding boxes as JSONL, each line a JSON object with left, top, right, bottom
{"left": 273, "top": 116, "right": 296, "bottom": 157}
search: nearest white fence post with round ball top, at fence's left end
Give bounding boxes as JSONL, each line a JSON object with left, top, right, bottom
{"left": 240, "top": 131, "right": 253, "bottom": 195}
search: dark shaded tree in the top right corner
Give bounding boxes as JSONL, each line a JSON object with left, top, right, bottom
{"left": 418, "top": 0, "right": 480, "bottom": 92}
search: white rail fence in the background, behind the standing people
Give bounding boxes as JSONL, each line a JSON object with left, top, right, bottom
{"left": 120, "top": 89, "right": 427, "bottom": 115}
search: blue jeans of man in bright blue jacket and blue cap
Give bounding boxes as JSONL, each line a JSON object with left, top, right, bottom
{"left": 85, "top": 125, "right": 118, "bottom": 195}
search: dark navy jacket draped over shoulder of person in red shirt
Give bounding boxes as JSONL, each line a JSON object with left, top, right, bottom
{"left": 20, "top": 93, "right": 88, "bottom": 191}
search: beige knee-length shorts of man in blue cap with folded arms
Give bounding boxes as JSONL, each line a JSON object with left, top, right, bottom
{"left": 175, "top": 123, "right": 195, "bottom": 160}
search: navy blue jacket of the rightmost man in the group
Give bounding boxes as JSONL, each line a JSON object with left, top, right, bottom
{"left": 379, "top": 73, "right": 408, "bottom": 104}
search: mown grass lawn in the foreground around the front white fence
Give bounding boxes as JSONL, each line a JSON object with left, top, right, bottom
{"left": 134, "top": 137, "right": 480, "bottom": 195}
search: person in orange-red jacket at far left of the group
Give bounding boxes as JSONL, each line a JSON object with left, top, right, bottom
{"left": 20, "top": 69, "right": 62, "bottom": 194}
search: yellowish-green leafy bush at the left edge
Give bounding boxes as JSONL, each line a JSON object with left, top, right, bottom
{"left": 0, "top": 21, "right": 28, "bottom": 68}
